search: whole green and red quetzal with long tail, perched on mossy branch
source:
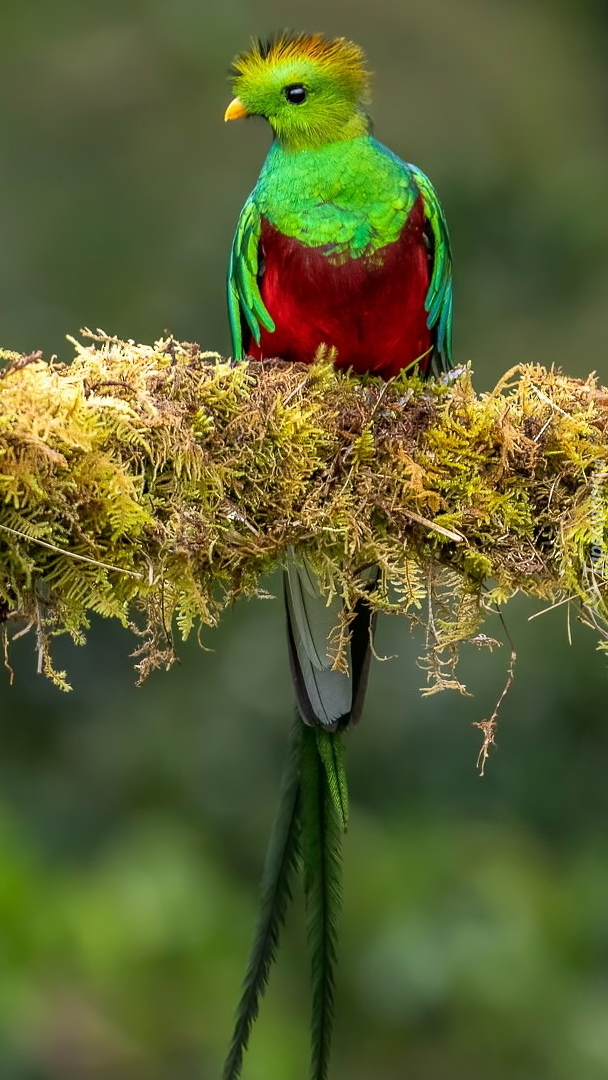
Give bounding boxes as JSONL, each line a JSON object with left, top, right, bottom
{"left": 224, "top": 33, "right": 451, "bottom": 1080}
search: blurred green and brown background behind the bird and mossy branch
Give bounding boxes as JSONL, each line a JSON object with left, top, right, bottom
{"left": 0, "top": 0, "right": 608, "bottom": 1080}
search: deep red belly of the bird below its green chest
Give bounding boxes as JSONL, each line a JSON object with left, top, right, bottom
{"left": 246, "top": 199, "right": 432, "bottom": 378}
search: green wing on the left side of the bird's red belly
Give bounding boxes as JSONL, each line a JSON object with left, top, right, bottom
{"left": 228, "top": 195, "right": 274, "bottom": 360}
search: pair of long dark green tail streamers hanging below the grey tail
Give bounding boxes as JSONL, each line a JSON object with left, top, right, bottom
{"left": 222, "top": 714, "right": 348, "bottom": 1080}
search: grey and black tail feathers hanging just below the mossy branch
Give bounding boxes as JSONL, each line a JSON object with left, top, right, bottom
{"left": 284, "top": 553, "right": 378, "bottom": 731}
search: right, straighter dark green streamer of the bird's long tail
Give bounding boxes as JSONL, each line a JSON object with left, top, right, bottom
{"left": 301, "top": 725, "right": 346, "bottom": 1080}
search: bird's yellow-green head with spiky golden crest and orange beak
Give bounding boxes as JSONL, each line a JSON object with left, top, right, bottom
{"left": 225, "top": 33, "right": 369, "bottom": 150}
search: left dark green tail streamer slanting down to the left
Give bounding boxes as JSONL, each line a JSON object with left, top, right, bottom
{"left": 222, "top": 716, "right": 303, "bottom": 1080}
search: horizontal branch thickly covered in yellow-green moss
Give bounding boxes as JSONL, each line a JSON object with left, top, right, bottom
{"left": 0, "top": 334, "right": 608, "bottom": 685}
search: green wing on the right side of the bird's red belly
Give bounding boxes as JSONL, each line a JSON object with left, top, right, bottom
{"left": 407, "top": 164, "right": 452, "bottom": 373}
